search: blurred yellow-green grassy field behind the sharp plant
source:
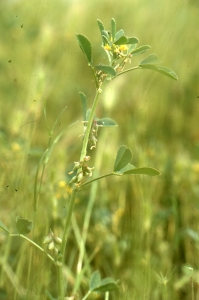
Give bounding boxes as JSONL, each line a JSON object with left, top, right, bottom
{"left": 0, "top": 0, "right": 199, "bottom": 300}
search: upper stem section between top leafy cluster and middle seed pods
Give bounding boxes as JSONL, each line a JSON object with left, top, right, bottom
{"left": 80, "top": 88, "right": 102, "bottom": 161}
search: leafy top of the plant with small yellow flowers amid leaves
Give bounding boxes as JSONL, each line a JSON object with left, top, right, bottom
{"left": 77, "top": 18, "right": 178, "bottom": 83}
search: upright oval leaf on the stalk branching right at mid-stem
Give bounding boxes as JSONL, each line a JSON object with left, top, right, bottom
{"left": 114, "top": 146, "right": 132, "bottom": 172}
